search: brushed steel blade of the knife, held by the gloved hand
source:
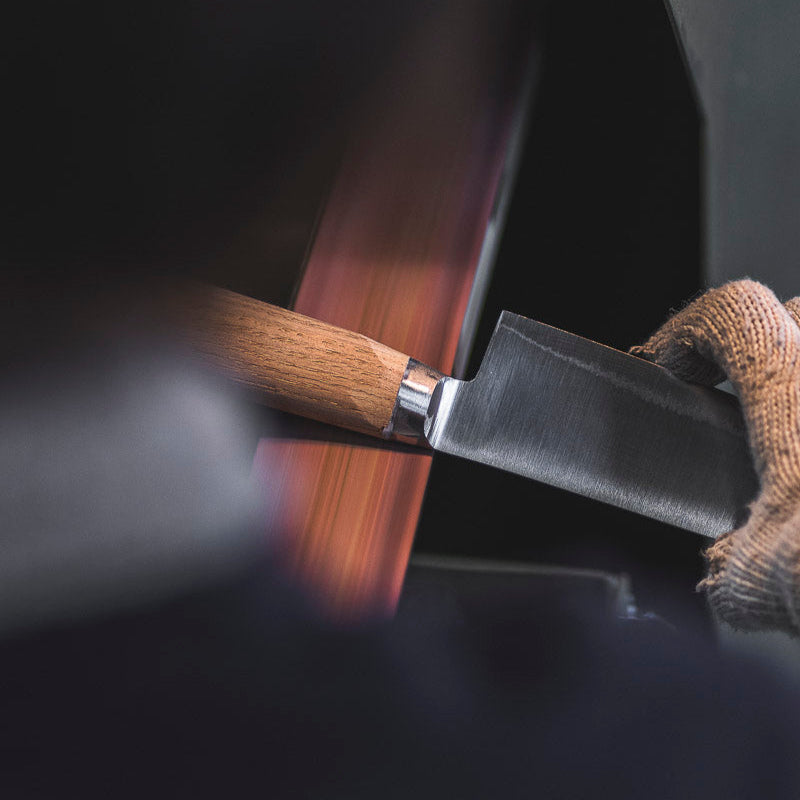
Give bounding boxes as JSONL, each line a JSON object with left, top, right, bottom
{"left": 425, "top": 311, "right": 758, "bottom": 536}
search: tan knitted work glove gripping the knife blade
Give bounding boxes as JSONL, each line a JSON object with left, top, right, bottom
{"left": 631, "top": 280, "right": 800, "bottom": 635}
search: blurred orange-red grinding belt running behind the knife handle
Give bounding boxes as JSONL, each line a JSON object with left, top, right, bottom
{"left": 254, "top": 2, "right": 536, "bottom": 622}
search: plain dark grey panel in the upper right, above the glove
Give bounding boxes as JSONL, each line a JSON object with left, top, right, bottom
{"left": 666, "top": 0, "right": 800, "bottom": 297}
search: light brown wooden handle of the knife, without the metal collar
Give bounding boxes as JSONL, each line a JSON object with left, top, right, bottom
{"left": 177, "top": 285, "right": 416, "bottom": 437}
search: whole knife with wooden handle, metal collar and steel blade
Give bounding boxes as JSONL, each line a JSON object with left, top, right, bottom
{"left": 173, "top": 286, "right": 758, "bottom": 537}
